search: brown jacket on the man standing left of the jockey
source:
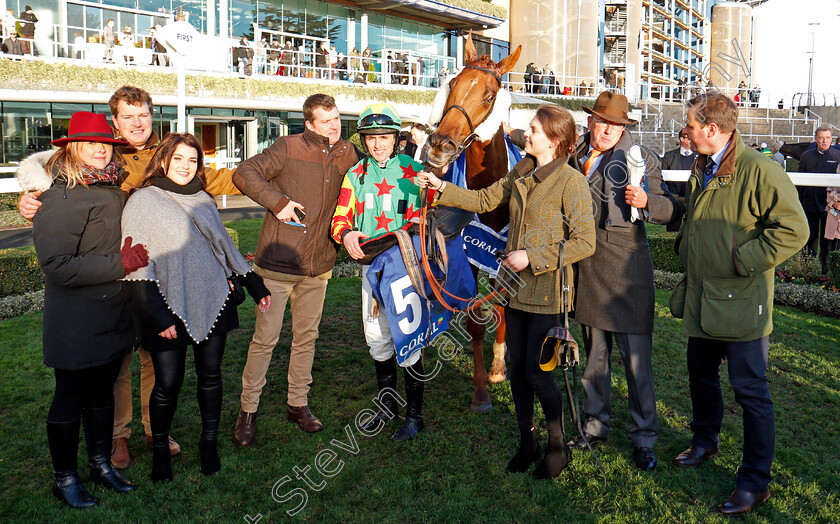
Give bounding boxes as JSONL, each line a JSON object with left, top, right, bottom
{"left": 233, "top": 129, "right": 359, "bottom": 277}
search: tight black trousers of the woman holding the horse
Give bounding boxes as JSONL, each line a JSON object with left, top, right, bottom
{"left": 505, "top": 307, "right": 563, "bottom": 430}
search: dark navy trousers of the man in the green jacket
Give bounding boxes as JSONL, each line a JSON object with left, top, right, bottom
{"left": 688, "top": 337, "right": 776, "bottom": 493}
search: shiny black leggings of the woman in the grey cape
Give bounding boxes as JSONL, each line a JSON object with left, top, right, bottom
{"left": 149, "top": 335, "right": 227, "bottom": 444}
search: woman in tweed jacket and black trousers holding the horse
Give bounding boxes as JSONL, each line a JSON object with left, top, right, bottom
{"left": 417, "top": 105, "right": 595, "bottom": 479}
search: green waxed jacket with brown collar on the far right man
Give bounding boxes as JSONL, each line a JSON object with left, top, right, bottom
{"left": 671, "top": 130, "right": 808, "bottom": 341}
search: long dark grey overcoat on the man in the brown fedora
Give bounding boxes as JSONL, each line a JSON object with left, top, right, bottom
{"left": 569, "top": 130, "right": 682, "bottom": 335}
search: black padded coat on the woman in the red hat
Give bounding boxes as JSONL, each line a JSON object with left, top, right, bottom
{"left": 32, "top": 181, "right": 138, "bottom": 370}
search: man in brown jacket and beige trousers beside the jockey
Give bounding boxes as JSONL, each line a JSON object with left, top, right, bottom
{"left": 233, "top": 94, "right": 359, "bottom": 440}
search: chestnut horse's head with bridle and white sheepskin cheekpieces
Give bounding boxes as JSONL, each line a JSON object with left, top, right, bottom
{"left": 426, "top": 37, "right": 522, "bottom": 167}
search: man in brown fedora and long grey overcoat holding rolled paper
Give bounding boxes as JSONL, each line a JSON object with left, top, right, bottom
{"left": 569, "top": 91, "right": 682, "bottom": 471}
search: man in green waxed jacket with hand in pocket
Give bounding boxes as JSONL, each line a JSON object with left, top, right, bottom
{"left": 671, "top": 93, "right": 808, "bottom": 515}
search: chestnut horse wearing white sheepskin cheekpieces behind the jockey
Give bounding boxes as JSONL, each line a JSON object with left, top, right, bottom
{"left": 426, "top": 36, "right": 522, "bottom": 413}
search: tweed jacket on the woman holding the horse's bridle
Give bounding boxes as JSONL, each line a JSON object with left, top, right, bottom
{"left": 437, "top": 156, "right": 595, "bottom": 314}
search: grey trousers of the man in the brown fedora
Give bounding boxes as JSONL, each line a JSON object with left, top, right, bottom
{"left": 581, "top": 326, "right": 659, "bottom": 448}
